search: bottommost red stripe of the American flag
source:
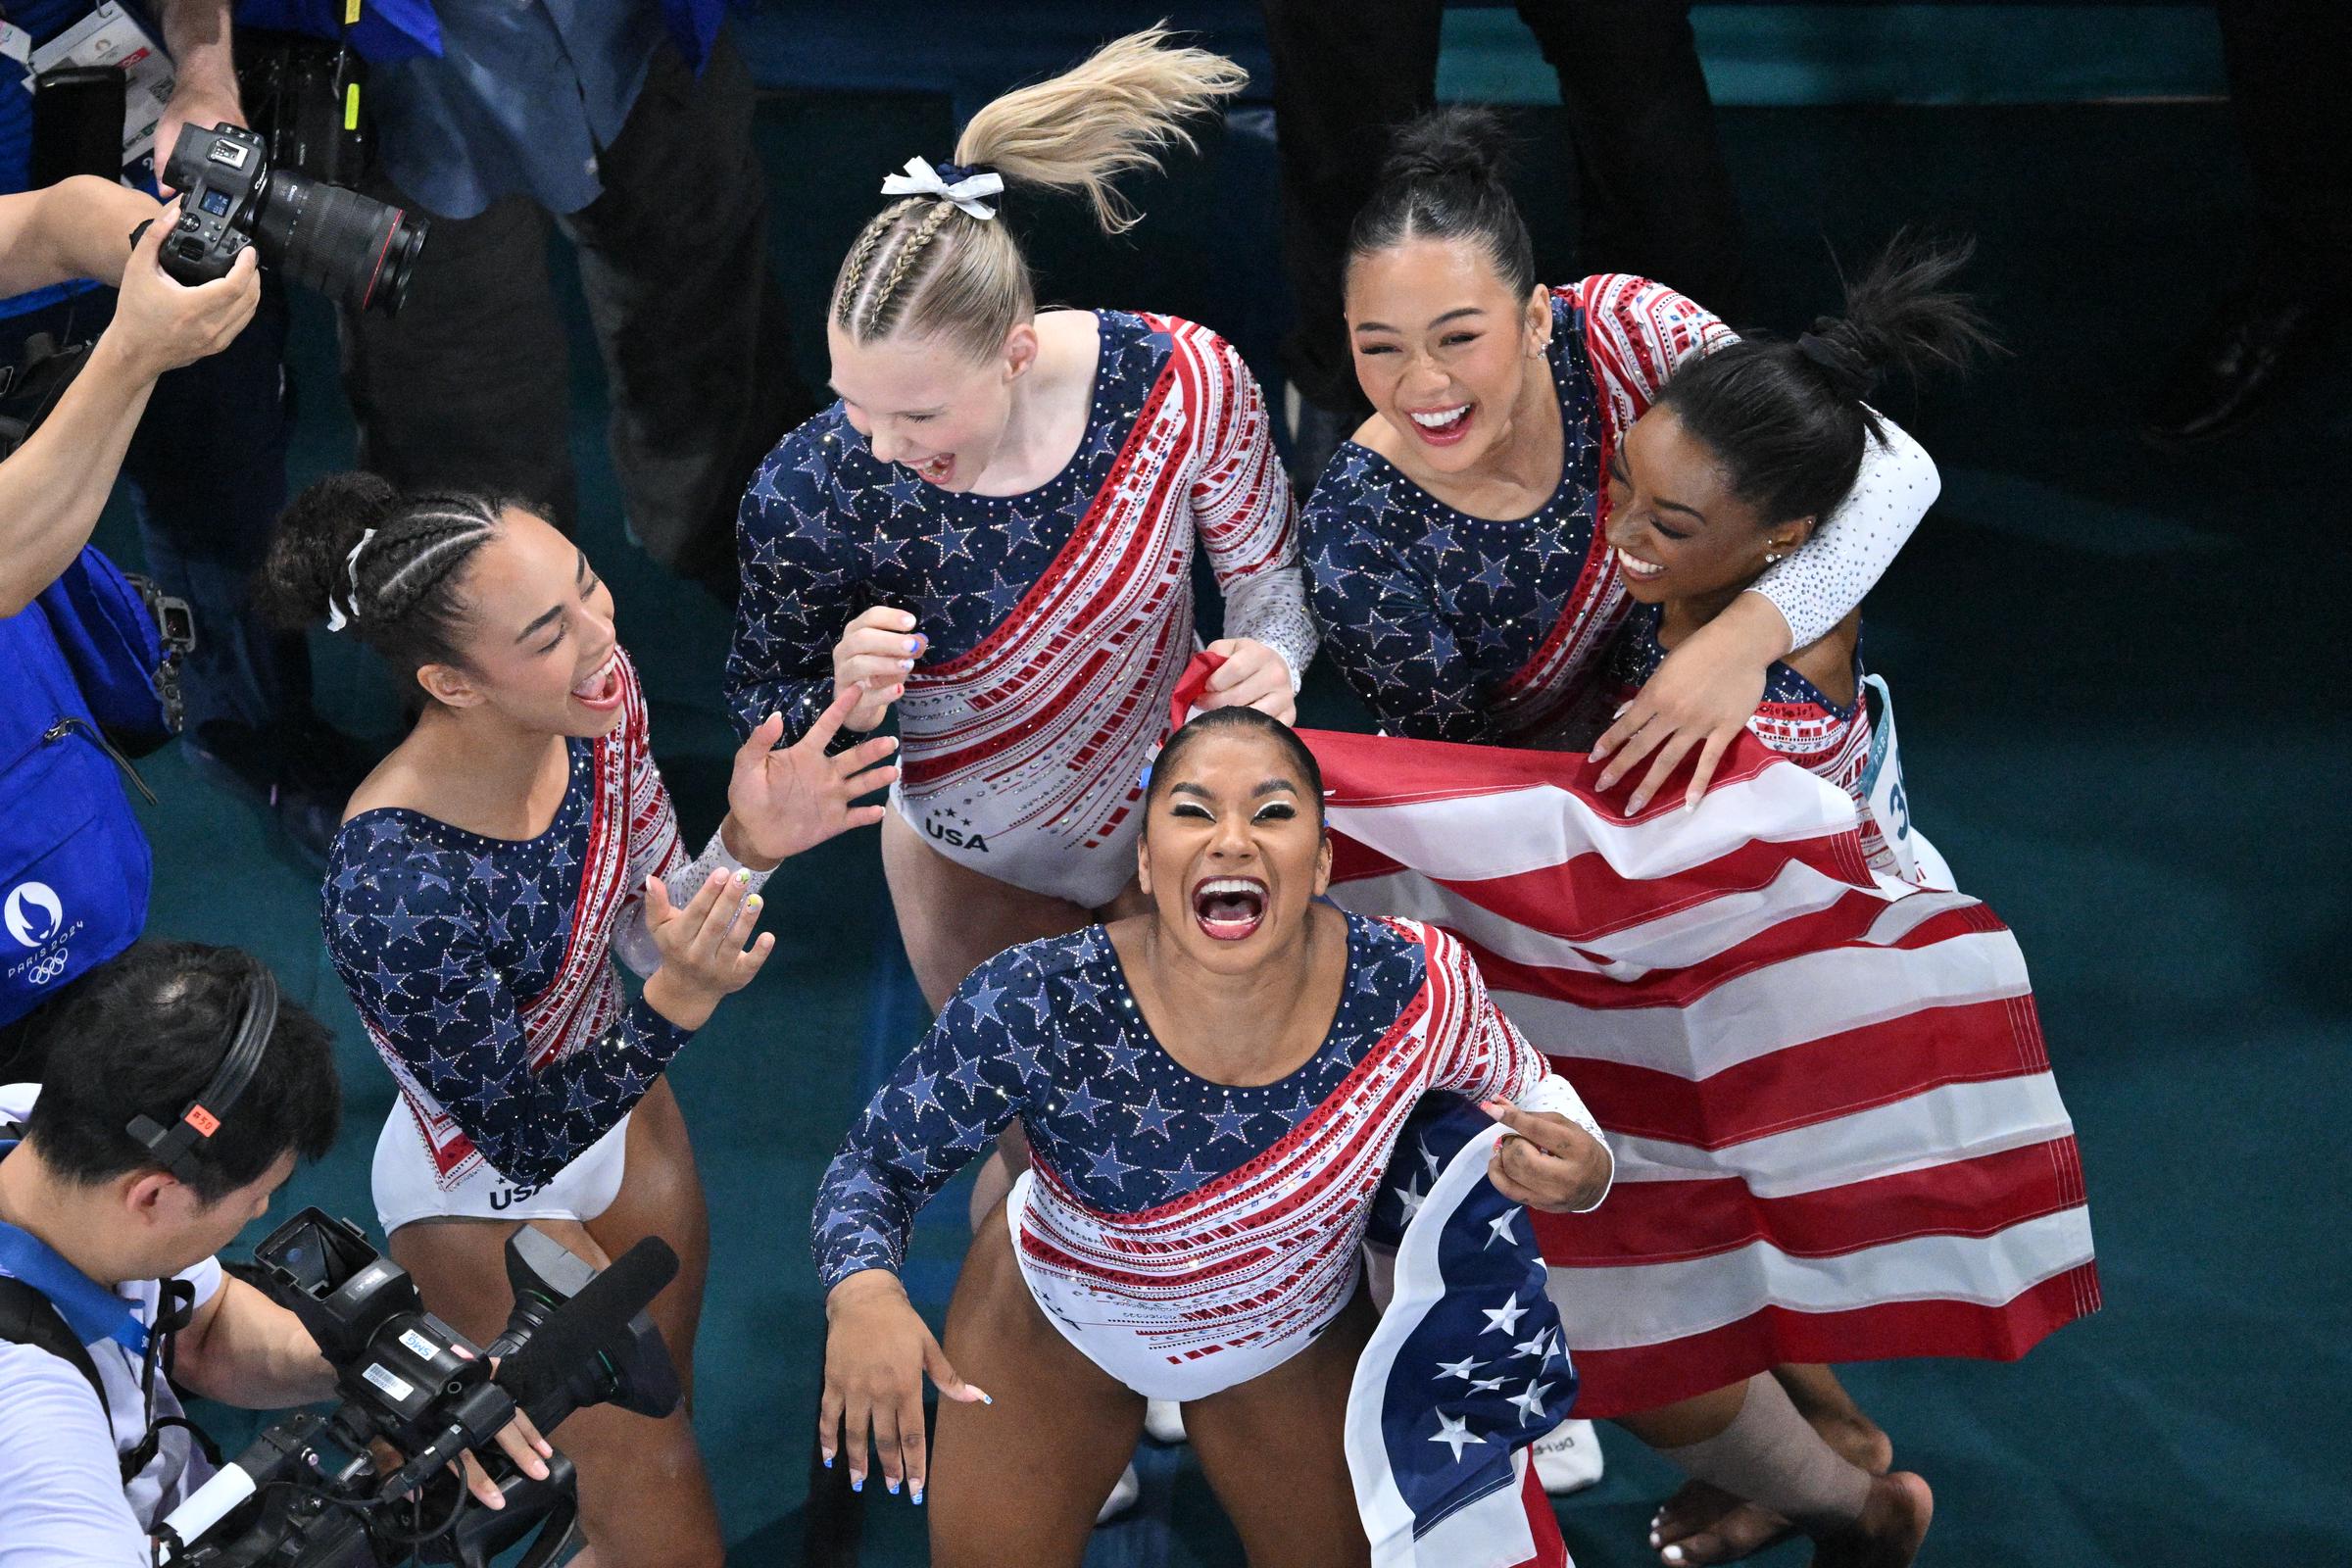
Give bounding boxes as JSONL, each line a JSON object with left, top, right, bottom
{"left": 1569, "top": 1259, "right": 2100, "bottom": 1417}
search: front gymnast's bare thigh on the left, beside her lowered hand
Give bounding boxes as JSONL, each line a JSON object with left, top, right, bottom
{"left": 927, "top": 1206, "right": 1143, "bottom": 1568}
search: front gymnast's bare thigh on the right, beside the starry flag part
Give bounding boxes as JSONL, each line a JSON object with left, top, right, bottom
{"left": 1183, "top": 1289, "right": 1374, "bottom": 1568}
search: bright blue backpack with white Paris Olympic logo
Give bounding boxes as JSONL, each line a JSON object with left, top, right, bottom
{"left": 0, "top": 550, "right": 172, "bottom": 1025}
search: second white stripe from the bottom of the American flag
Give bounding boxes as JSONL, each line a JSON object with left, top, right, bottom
{"left": 1609, "top": 1072, "right": 2075, "bottom": 1199}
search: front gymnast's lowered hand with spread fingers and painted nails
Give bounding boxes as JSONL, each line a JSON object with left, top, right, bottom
{"left": 816, "top": 1269, "right": 995, "bottom": 1502}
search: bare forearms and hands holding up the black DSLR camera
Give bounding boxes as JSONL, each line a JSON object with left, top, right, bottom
{"left": 0, "top": 184, "right": 261, "bottom": 615}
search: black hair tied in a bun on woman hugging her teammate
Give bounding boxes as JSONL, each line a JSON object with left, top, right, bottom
{"left": 1348, "top": 108, "right": 1536, "bottom": 299}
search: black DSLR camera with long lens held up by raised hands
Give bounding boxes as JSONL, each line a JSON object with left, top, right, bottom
{"left": 163, "top": 122, "right": 428, "bottom": 315}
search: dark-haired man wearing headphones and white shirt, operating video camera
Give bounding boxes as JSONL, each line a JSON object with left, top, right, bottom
{"left": 0, "top": 943, "right": 553, "bottom": 1568}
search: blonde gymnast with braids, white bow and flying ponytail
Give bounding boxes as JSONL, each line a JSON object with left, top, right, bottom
{"left": 727, "top": 28, "right": 1315, "bottom": 1034}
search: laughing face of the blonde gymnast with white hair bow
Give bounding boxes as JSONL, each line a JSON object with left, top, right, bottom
{"left": 825, "top": 322, "right": 1037, "bottom": 491}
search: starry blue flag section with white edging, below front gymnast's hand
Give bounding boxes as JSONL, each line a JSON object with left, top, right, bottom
{"left": 1348, "top": 1096, "right": 1576, "bottom": 1568}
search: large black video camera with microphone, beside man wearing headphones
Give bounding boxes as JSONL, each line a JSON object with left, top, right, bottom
{"left": 158, "top": 1208, "right": 677, "bottom": 1568}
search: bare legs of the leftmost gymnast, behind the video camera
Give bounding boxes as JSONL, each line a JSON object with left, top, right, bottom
{"left": 388, "top": 1081, "right": 727, "bottom": 1568}
